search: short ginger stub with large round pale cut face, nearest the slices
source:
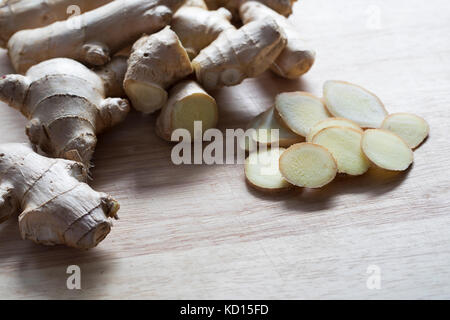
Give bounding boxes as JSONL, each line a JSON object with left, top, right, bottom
{"left": 156, "top": 80, "right": 218, "bottom": 141}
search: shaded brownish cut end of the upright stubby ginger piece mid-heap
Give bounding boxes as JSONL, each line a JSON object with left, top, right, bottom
{"left": 124, "top": 80, "right": 168, "bottom": 113}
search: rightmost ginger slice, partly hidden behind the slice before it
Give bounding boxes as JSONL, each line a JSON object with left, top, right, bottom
{"left": 381, "top": 113, "right": 430, "bottom": 149}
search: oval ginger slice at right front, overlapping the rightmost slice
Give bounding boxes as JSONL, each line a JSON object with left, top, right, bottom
{"left": 361, "top": 129, "right": 414, "bottom": 171}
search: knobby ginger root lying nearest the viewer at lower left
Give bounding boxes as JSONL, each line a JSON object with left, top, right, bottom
{"left": 0, "top": 144, "right": 119, "bottom": 249}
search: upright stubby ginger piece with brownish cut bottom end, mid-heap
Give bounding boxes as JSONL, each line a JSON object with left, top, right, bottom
{"left": 123, "top": 27, "right": 193, "bottom": 113}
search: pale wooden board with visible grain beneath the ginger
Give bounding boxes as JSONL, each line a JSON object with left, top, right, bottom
{"left": 0, "top": 0, "right": 450, "bottom": 299}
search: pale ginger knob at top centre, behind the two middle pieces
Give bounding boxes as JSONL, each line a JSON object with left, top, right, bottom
{"left": 171, "top": 5, "right": 235, "bottom": 59}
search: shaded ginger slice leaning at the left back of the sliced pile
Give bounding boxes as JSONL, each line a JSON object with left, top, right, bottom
{"left": 247, "top": 107, "right": 303, "bottom": 147}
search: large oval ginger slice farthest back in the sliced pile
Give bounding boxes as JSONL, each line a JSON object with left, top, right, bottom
{"left": 323, "top": 80, "right": 388, "bottom": 128}
